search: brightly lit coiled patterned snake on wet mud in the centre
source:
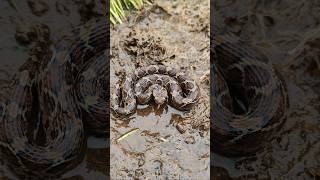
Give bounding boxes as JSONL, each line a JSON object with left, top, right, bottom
{"left": 110, "top": 65, "right": 200, "bottom": 116}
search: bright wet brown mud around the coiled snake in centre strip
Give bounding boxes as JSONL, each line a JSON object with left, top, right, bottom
{"left": 110, "top": 0, "right": 210, "bottom": 179}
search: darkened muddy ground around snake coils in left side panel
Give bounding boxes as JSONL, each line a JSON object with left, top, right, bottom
{"left": 0, "top": 0, "right": 109, "bottom": 179}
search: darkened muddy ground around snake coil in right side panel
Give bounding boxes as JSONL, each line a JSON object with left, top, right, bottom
{"left": 211, "top": 0, "right": 320, "bottom": 179}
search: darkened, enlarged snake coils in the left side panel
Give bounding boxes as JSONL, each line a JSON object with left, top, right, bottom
{"left": 0, "top": 17, "right": 110, "bottom": 178}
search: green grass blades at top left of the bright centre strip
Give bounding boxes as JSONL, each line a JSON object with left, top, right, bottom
{"left": 110, "top": 0, "right": 149, "bottom": 24}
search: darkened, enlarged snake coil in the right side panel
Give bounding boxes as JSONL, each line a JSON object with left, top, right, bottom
{"left": 210, "top": 27, "right": 289, "bottom": 157}
